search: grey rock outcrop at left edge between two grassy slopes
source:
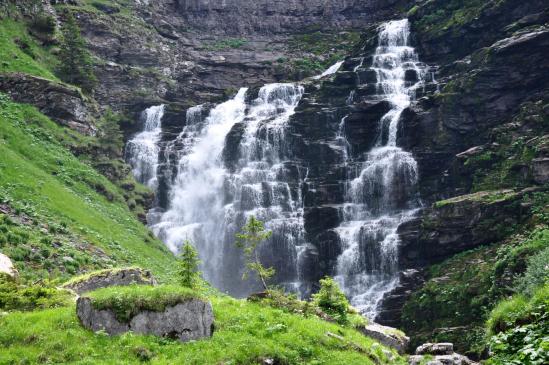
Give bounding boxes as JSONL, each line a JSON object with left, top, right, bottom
{"left": 0, "top": 73, "right": 97, "bottom": 135}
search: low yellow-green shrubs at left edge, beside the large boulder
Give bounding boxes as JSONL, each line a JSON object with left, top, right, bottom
{"left": 0, "top": 273, "right": 72, "bottom": 311}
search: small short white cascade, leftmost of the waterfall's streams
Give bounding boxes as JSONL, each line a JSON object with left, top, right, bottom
{"left": 124, "top": 105, "right": 164, "bottom": 188}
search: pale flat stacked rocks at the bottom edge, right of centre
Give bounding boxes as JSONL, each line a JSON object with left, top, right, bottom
{"left": 408, "top": 342, "right": 477, "bottom": 365}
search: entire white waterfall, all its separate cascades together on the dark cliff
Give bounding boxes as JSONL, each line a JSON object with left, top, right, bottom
{"left": 126, "top": 19, "right": 428, "bottom": 318}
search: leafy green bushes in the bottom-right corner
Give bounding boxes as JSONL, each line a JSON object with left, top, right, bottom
{"left": 487, "top": 284, "right": 549, "bottom": 365}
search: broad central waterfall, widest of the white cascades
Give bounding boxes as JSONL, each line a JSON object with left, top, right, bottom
{"left": 152, "top": 84, "right": 305, "bottom": 294}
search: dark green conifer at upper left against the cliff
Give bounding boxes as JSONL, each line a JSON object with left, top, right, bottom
{"left": 59, "top": 12, "right": 97, "bottom": 93}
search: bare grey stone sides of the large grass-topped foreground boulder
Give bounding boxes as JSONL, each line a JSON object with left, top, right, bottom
{"left": 76, "top": 297, "right": 214, "bottom": 342}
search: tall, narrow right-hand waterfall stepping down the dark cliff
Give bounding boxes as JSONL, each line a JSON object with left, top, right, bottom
{"left": 336, "top": 19, "right": 426, "bottom": 319}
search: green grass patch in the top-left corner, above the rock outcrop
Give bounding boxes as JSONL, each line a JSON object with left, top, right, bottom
{"left": 0, "top": 19, "right": 57, "bottom": 80}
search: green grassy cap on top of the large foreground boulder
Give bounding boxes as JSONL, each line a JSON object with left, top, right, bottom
{"left": 86, "top": 285, "right": 202, "bottom": 322}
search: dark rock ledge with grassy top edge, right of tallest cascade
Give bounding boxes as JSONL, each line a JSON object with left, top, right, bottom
{"left": 399, "top": 190, "right": 528, "bottom": 267}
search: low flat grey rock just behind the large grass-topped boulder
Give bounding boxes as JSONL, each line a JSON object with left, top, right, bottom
{"left": 63, "top": 268, "right": 156, "bottom": 294}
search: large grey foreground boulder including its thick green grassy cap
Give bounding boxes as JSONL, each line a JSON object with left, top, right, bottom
{"left": 76, "top": 285, "right": 214, "bottom": 342}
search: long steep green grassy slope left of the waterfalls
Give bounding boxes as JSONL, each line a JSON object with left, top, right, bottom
{"left": 0, "top": 96, "right": 175, "bottom": 278}
